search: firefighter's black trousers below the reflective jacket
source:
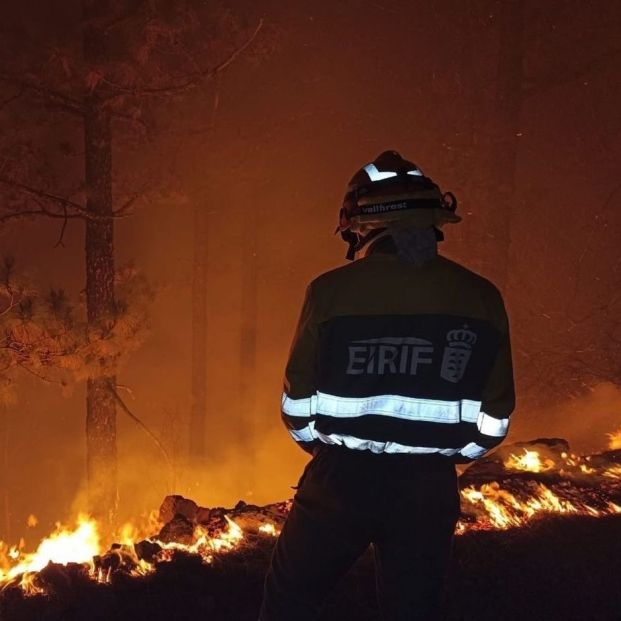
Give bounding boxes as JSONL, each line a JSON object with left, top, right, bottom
{"left": 259, "top": 446, "right": 459, "bottom": 621}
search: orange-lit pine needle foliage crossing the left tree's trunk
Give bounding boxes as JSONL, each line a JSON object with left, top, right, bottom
{"left": 0, "top": 257, "right": 152, "bottom": 524}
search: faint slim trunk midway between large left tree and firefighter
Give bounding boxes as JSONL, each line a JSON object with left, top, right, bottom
{"left": 189, "top": 201, "right": 208, "bottom": 464}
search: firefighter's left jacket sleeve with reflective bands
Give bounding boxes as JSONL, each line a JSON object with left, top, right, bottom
{"left": 281, "top": 283, "right": 320, "bottom": 453}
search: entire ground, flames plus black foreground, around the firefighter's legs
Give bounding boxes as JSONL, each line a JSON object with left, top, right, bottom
{"left": 0, "top": 434, "right": 621, "bottom": 621}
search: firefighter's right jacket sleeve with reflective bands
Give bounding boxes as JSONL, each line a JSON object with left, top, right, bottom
{"left": 460, "top": 292, "right": 515, "bottom": 461}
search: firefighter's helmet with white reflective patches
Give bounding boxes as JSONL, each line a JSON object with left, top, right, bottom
{"left": 335, "top": 151, "right": 461, "bottom": 260}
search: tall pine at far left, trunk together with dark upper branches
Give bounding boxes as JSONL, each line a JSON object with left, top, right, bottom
{"left": 0, "top": 0, "right": 261, "bottom": 521}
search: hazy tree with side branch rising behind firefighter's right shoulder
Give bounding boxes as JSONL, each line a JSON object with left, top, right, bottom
{"left": 477, "top": 0, "right": 621, "bottom": 289}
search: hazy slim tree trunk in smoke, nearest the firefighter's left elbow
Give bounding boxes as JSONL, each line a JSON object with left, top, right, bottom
{"left": 237, "top": 209, "right": 258, "bottom": 485}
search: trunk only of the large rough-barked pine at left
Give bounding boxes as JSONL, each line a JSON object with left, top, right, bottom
{"left": 83, "top": 0, "right": 117, "bottom": 523}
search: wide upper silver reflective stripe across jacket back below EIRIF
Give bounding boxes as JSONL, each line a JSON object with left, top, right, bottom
{"left": 316, "top": 392, "right": 481, "bottom": 423}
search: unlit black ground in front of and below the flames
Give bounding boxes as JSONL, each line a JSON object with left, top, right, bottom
{"left": 0, "top": 516, "right": 621, "bottom": 621}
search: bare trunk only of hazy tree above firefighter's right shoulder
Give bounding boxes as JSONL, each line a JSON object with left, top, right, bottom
{"left": 477, "top": 0, "right": 524, "bottom": 290}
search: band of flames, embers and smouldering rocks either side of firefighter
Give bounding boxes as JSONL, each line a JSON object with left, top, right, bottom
{"left": 0, "top": 440, "right": 621, "bottom": 595}
